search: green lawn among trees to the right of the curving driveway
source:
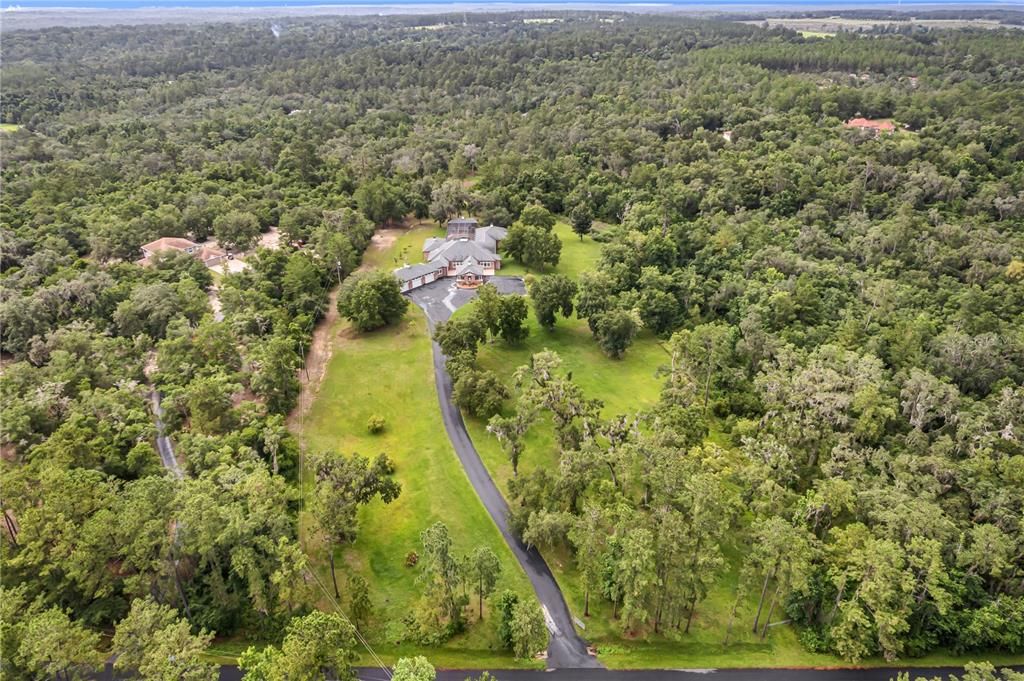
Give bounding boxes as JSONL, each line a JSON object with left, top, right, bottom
{"left": 459, "top": 319, "right": 1022, "bottom": 669}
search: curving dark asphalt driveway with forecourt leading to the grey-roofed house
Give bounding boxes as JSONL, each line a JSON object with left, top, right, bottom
{"left": 410, "top": 276, "right": 601, "bottom": 669}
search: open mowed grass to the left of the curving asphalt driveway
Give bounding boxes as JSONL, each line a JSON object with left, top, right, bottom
{"left": 297, "top": 222, "right": 535, "bottom": 668}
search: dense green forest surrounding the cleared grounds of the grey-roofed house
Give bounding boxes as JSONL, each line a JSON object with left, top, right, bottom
{"left": 0, "top": 13, "right": 1024, "bottom": 678}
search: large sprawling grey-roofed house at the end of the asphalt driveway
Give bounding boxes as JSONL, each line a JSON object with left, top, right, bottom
{"left": 394, "top": 217, "right": 507, "bottom": 291}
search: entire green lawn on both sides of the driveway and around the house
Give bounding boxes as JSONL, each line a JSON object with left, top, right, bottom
{"left": 286, "top": 225, "right": 1020, "bottom": 669}
